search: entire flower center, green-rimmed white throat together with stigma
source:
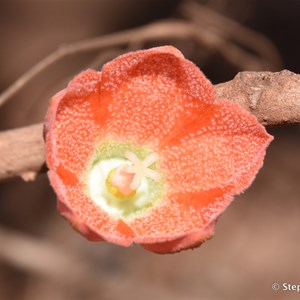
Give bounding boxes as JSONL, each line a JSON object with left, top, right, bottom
{"left": 84, "top": 141, "right": 165, "bottom": 220}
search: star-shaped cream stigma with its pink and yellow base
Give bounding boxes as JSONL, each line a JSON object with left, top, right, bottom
{"left": 105, "top": 151, "right": 160, "bottom": 200}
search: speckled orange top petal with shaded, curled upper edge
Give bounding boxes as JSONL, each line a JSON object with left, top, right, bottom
{"left": 100, "top": 46, "right": 215, "bottom": 144}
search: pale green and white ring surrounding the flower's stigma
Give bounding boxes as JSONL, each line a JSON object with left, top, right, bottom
{"left": 85, "top": 141, "right": 163, "bottom": 219}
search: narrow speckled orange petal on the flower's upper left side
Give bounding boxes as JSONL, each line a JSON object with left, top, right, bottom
{"left": 45, "top": 70, "right": 101, "bottom": 176}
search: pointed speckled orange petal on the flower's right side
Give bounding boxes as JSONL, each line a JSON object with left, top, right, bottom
{"left": 160, "top": 101, "right": 272, "bottom": 194}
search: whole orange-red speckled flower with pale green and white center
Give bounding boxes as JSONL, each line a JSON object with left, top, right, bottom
{"left": 45, "top": 46, "right": 272, "bottom": 253}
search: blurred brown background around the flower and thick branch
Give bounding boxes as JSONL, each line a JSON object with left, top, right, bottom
{"left": 0, "top": 0, "right": 300, "bottom": 300}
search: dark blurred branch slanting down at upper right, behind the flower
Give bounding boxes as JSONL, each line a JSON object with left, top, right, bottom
{"left": 179, "top": 1, "right": 282, "bottom": 71}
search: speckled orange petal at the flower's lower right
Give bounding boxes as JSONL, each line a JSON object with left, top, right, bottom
{"left": 128, "top": 189, "right": 232, "bottom": 247}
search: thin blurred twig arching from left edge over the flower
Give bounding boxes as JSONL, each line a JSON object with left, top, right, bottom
{"left": 0, "top": 17, "right": 281, "bottom": 106}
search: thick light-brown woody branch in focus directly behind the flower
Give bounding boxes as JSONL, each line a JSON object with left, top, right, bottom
{"left": 0, "top": 70, "right": 300, "bottom": 181}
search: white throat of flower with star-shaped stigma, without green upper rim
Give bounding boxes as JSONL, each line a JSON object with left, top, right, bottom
{"left": 87, "top": 151, "right": 161, "bottom": 217}
